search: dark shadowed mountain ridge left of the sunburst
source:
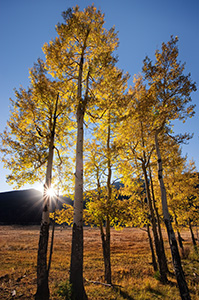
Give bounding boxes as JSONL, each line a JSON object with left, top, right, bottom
{"left": 0, "top": 189, "right": 72, "bottom": 225}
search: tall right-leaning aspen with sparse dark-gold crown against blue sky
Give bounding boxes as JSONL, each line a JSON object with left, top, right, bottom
{"left": 143, "top": 36, "right": 196, "bottom": 300}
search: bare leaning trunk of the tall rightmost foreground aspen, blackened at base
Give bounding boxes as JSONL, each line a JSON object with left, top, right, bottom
{"left": 155, "top": 132, "right": 191, "bottom": 300}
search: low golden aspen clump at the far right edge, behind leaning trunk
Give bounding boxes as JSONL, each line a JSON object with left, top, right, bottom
{"left": 165, "top": 157, "right": 199, "bottom": 252}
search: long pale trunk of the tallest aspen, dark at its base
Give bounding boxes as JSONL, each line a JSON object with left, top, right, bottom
{"left": 70, "top": 43, "right": 89, "bottom": 300}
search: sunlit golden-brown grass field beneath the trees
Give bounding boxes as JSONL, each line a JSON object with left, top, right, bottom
{"left": 0, "top": 226, "right": 199, "bottom": 300}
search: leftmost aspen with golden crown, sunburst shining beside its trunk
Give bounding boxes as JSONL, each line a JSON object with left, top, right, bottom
{"left": 1, "top": 60, "right": 71, "bottom": 300}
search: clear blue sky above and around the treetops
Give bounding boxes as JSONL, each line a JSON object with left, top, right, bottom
{"left": 0, "top": 0, "right": 199, "bottom": 192}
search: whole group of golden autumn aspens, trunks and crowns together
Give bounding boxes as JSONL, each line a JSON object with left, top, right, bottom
{"left": 1, "top": 5, "right": 198, "bottom": 300}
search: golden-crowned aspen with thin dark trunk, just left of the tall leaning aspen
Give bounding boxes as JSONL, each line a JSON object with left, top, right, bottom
{"left": 117, "top": 76, "right": 167, "bottom": 283}
